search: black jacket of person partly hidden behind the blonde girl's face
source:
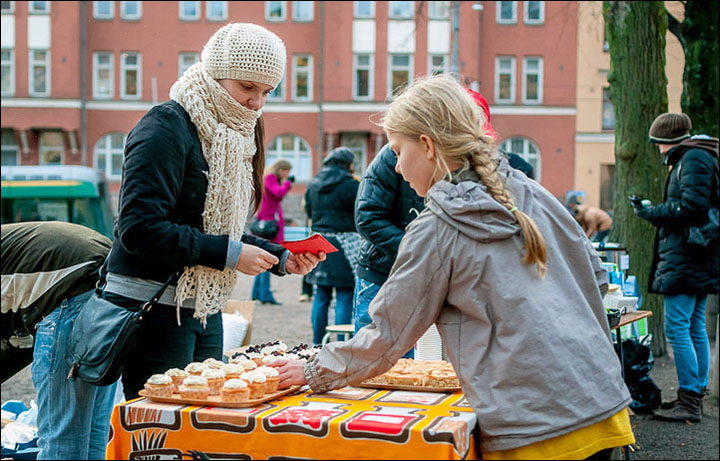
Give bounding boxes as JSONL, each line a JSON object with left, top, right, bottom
{"left": 355, "top": 145, "right": 425, "bottom": 284}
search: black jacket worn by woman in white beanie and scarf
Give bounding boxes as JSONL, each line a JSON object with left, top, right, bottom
{"left": 108, "top": 101, "right": 285, "bottom": 282}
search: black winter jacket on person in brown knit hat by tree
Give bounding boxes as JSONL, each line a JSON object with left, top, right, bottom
{"left": 649, "top": 138, "right": 720, "bottom": 295}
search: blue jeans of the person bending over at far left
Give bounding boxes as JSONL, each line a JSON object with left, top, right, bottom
{"left": 31, "top": 290, "right": 117, "bottom": 459}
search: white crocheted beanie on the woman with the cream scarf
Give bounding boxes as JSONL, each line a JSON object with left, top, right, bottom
{"left": 202, "top": 23, "right": 286, "bottom": 88}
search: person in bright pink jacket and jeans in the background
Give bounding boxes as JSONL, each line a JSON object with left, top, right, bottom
{"left": 251, "top": 160, "right": 294, "bottom": 305}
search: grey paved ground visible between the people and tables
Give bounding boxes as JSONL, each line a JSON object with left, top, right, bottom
{"left": 2, "top": 276, "right": 719, "bottom": 460}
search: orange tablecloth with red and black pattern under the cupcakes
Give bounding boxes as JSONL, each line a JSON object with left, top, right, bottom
{"left": 107, "top": 387, "right": 477, "bottom": 459}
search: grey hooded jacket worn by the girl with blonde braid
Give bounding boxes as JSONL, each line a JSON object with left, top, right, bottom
{"left": 305, "top": 160, "right": 632, "bottom": 451}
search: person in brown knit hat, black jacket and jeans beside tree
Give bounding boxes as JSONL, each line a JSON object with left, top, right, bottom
{"left": 633, "top": 113, "right": 720, "bottom": 422}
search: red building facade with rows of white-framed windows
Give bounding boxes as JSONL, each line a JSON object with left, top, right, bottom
{"left": 2, "top": 1, "right": 578, "bottom": 216}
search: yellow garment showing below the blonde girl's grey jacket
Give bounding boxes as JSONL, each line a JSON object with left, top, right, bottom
{"left": 482, "top": 408, "right": 635, "bottom": 459}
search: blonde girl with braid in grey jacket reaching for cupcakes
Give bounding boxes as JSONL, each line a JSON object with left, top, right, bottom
{"left": 273, "top": 76, "right": 634, "bottom": 459}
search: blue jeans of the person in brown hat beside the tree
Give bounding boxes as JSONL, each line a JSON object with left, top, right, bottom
{"left": 665, "top": 295, "right": 710, "bottom": 393}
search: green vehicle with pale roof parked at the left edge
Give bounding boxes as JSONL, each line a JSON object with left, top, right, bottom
{"left": 1, "top": 165, "right": 113, "bottom": 238}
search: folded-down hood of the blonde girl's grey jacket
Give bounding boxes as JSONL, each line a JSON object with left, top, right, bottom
{"left": 426, "top": 159, "right": 533, "bottom": 242}
